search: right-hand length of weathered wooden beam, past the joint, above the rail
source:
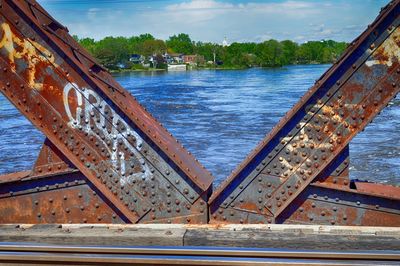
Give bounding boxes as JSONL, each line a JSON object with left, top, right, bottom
{"left": 184, "top": 229, "right": 400, "bottom": 250}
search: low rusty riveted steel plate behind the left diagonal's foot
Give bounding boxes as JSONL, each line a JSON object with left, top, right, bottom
{"left": 0, "top": 171, "right": 127, "bottom": 224}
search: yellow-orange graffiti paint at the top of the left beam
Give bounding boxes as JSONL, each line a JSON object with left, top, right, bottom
{"left": 0, "top": 23, "right": 58, "bottom": 90}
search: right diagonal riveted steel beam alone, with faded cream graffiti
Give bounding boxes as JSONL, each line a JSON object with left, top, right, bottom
{"left": 209, "top": 0, "right": 400, "bottom": 223}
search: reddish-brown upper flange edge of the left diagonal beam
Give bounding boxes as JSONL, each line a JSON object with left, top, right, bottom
{"left": 7, "top": 0, "right": 214, "bottom": 190}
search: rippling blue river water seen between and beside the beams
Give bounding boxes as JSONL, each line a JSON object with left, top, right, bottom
{"left": 0, "top": 65, "right": 400, "bottom": 184}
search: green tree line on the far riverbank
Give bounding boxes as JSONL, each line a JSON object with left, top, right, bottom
{"left": 74, "top": 33, "right": 348, "bottom": 69}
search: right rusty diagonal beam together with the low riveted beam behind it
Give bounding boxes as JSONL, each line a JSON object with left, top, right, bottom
{"left": 209, "top": 0, "right": 400, "bottom": 226}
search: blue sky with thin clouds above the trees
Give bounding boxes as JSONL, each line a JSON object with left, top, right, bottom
{"left": 38, "top": 0, "right": 389, "bottom": 43}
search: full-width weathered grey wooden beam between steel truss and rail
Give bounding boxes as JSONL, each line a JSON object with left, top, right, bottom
{"left": 0, "top": 224, "right": 400, "bottom": 250}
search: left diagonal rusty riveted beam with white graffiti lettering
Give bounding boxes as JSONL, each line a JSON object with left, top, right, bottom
{"left": 0, "top": 0, "right": 213, "bottom": 223}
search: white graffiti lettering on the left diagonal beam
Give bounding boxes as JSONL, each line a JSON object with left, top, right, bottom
{"left": 63, "top": 83, "right": 152, "bottom": 185}
